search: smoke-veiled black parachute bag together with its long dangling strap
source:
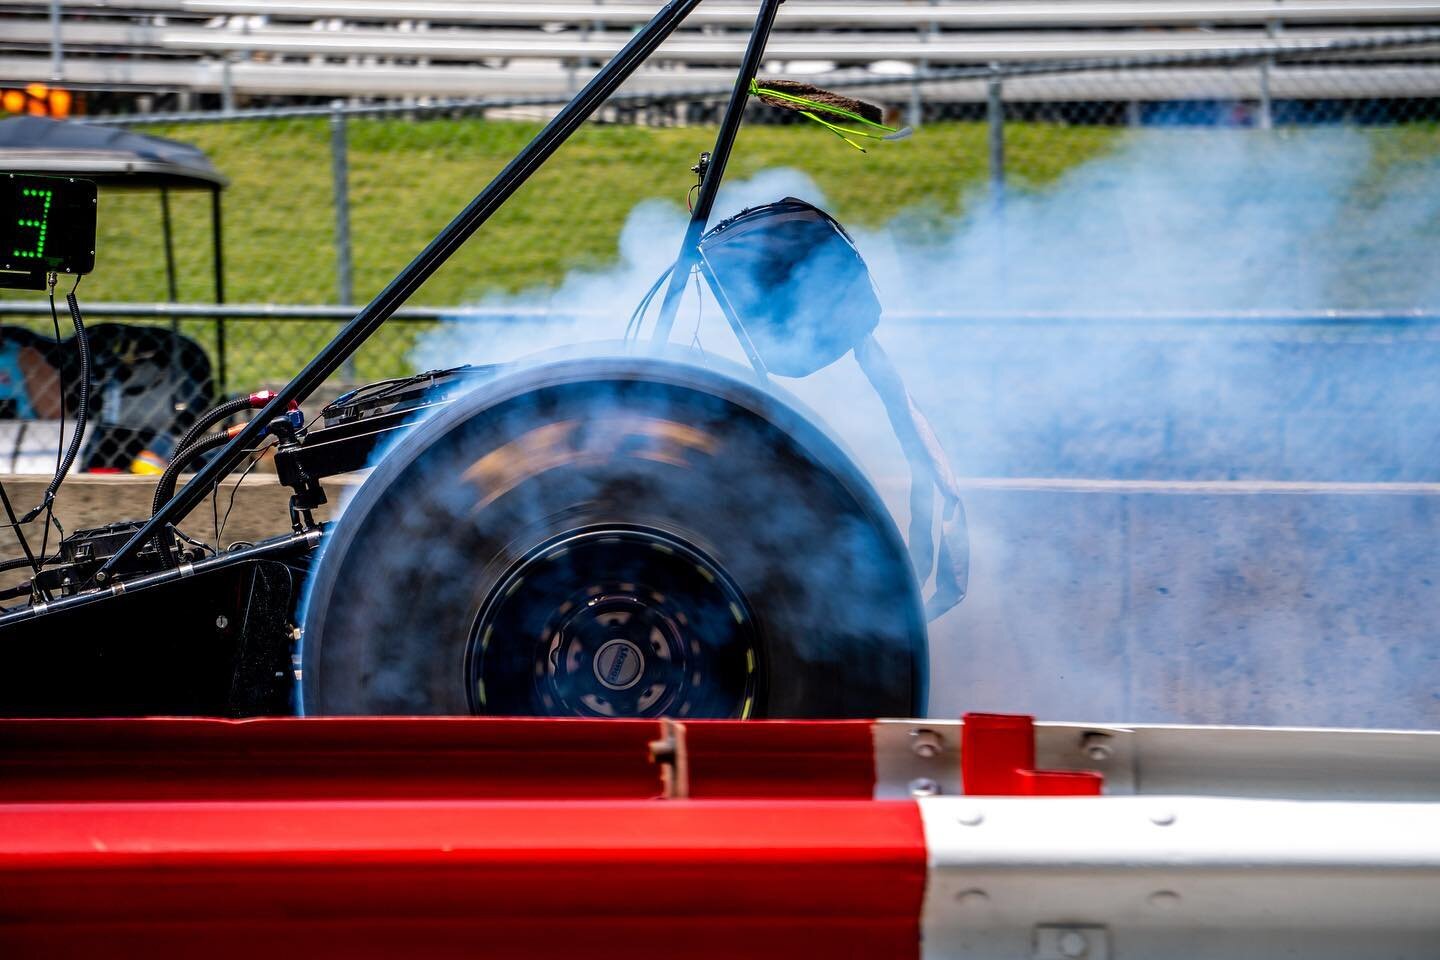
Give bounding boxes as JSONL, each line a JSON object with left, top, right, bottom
{"left": 700, "top": 197, "right": 969, "bottom": 620}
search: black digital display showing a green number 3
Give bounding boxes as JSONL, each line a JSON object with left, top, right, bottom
{"left": 0, "top": 174, "right": 96, "bottom": 285}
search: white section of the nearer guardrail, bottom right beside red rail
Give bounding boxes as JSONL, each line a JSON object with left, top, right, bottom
{"left": 919, "top": 797, "right": 1440, "bottom": 960}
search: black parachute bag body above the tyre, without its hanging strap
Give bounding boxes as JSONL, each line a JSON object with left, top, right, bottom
{"left": 700, "top": 197, "right": 880, "bottom": 377}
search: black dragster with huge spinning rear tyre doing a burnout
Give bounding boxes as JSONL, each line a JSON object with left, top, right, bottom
{"left": 0, "top": 0, "right": 968, "bottom": 718}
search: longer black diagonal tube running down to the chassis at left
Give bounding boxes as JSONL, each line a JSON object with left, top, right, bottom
{"left": 94, "top": 0, "right": 714, "bottom": 581}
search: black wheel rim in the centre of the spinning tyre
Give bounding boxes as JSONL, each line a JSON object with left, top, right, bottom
{"left": 467, "top": 527, "right": 762, "bottom": 718}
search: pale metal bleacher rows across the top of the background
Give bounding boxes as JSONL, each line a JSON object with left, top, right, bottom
{"left": 0, "top": 0, "right": 1440, "bottom": 101}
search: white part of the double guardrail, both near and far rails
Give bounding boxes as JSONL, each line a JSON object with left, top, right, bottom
{"left": 874, "top": 720, "right": 1440, "bottom": 960}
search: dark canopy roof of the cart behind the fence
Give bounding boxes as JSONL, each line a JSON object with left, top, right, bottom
{"left": 0, "top": 117, "right": 229, "bottom": 190}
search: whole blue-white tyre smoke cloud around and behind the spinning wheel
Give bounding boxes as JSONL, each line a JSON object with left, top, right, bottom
{"left": 388, "top": 128, "right": 1440, "bottom": 727}
